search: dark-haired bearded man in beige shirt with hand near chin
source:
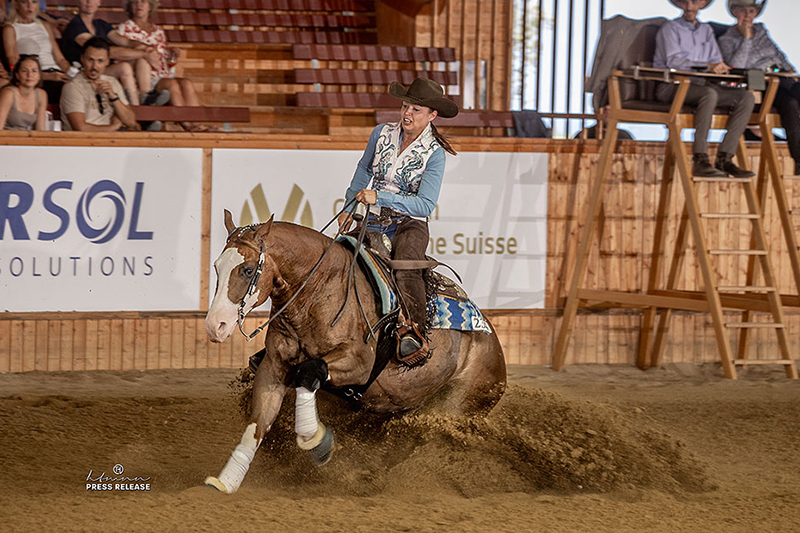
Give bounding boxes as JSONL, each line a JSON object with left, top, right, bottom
{"left": 61, "top": 37, "right": 137, "bottom": 131}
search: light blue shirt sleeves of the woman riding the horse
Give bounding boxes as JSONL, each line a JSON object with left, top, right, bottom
{"left": 344, "top": 124, "right": 445, "bottom": 217}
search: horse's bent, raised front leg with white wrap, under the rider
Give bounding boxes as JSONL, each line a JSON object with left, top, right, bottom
{"left": 295, "top": 347, "right": 370, "bottom": 466}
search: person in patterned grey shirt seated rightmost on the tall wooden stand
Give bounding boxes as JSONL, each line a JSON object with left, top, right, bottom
{"left": 719, "top": 0, "right": 800, "bottom": 175}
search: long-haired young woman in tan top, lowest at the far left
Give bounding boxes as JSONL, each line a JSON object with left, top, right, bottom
{"left": 0, "top": 55, "right": 47, "bottom": 131}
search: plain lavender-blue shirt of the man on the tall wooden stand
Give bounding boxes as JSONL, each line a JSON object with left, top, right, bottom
{"left": 653, "top": 17, "right": 722, "bottom": 70}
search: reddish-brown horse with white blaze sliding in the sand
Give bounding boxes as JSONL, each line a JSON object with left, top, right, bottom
{"left": 205, "top": 210, "right": 506, "bottom": 493}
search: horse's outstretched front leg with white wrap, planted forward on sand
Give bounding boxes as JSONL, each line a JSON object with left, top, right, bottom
{"left": 205, "top": 350, "right": 287, "bottom": 494}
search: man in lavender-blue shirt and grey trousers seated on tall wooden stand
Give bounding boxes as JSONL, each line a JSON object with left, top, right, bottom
{"left": 653, "top": 0, "right": 755, "bottom": 178}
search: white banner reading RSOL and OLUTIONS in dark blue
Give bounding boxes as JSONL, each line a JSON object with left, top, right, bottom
{"left": 0, "top": 146, "right": 202, "bottom": 312}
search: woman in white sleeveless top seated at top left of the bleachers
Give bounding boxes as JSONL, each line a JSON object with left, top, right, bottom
{"left": 3, "top": 0, "right": 69, "bottom": 102}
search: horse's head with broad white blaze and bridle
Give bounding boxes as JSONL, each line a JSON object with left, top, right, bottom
{"left": 206, "top": 209, "right": 283, "bottom": 342}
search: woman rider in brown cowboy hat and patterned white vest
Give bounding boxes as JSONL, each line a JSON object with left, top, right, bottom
{"left": 339, "top": 78, "right": 458, "bottom": 361}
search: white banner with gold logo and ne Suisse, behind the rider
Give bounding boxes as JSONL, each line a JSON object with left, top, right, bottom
{"left": 209, "top": 149, "right": 548, "bottom": 309}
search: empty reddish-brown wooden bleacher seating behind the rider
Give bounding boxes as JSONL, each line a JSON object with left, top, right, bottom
{"left": 43, "top": 0, "right": 513, "bottom": 135}
